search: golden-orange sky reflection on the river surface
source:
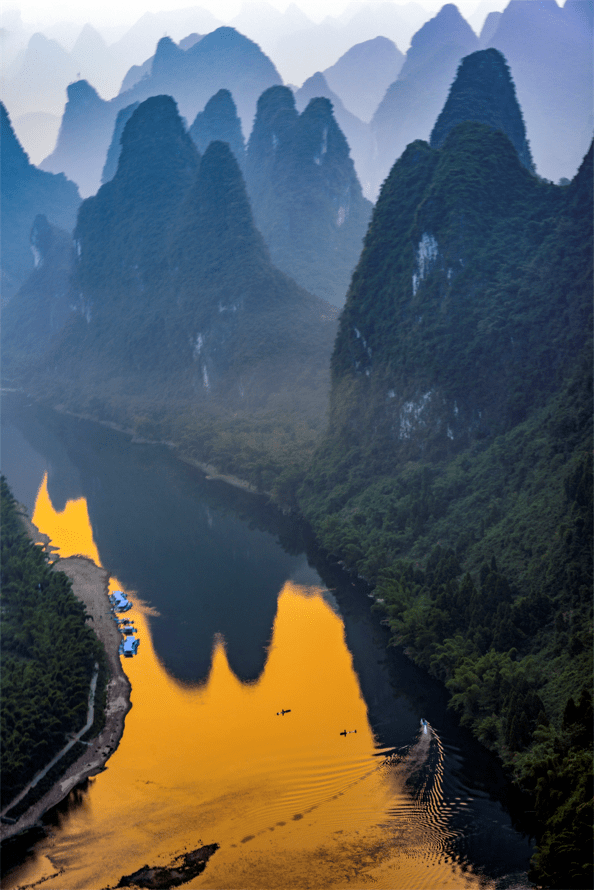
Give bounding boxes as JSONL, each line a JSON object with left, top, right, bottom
{"left": 5, "top": 479, "right": 489, "bottom": 890}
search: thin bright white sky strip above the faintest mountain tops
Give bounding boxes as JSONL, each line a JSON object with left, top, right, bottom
{"left": 3, "top": 0, "right": 508, "bottom": 27}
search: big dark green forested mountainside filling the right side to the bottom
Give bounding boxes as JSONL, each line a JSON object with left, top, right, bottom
{"left": 297, "top": 124, "right": 592, "bottom": 888}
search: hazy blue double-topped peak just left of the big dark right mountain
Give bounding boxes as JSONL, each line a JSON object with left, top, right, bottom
{"left": 246, "top": 87, "right": 371, "bottom": 306}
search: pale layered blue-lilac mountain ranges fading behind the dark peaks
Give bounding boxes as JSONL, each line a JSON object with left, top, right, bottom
{"left": 5, "top": 0, "right": 594, "bottom": 200}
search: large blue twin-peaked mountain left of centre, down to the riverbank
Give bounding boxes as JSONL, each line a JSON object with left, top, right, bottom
{"left": 2, "top": 96, "right": 338, "bottom": 490}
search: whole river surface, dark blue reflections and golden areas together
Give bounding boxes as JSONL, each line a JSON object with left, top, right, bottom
{"left": 2, "top": 394, "right": 532, "bottom": 890}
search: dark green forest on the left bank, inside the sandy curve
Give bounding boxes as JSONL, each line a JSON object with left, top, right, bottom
{"left": 0, "top": 477, "right": 105, "bottom": 807}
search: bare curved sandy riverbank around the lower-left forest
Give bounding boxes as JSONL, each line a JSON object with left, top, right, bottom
{"left": 0, "top": 516, "right": 131, "bottom": 840}
